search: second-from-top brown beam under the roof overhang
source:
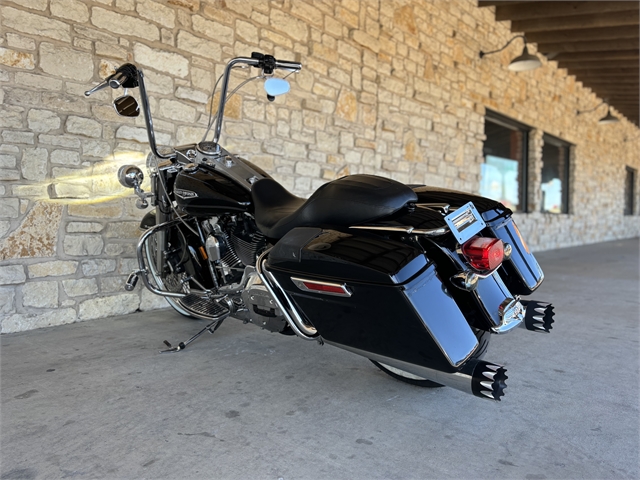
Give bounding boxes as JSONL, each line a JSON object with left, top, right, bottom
{"left": 511, "top": 10, "right": 638, "bottom": 32}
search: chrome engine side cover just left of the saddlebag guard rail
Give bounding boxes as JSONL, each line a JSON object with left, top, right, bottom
{"left": 242, "top": 271, "right": 288, "bottom": 332}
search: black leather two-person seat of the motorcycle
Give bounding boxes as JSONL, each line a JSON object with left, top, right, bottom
{"left": 251, "top": 175, "right": 418, "bottom": 238}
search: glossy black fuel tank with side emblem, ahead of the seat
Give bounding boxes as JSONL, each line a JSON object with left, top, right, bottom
{"left": 173, "top": 165, "right": 251, "bottom": 216}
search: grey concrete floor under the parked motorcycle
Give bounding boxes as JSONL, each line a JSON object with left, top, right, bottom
{"left": 0, "top": 239, "right": 640, "bottom": 480}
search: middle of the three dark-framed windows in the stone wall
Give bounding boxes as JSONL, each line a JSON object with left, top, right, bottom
{"left": 540, "top": 133, "right": 571, "bottom": 213}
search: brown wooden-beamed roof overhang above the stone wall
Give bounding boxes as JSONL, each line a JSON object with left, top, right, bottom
{"left": 478, "top": 0, "right": 640, "bottom": 125}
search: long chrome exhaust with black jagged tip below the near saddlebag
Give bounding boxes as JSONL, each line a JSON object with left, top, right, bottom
{"left": 324, "top": 339, "right": 509, "bottom": 402}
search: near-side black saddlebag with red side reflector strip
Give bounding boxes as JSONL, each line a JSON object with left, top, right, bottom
{"left": 265, "top": 228, "right": 478, "bottom": 372}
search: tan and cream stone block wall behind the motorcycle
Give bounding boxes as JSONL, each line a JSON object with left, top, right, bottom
{"left": 0, "top": 0, "right": 640, "bottom": 332}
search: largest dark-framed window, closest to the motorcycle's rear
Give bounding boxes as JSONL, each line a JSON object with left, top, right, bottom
{"left": 480, "top": 111, "right": 530, "bottom": 212}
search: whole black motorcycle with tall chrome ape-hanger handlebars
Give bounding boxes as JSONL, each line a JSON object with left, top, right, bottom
{"left": 85, "top": 53, "right": 554, "bottom": 400}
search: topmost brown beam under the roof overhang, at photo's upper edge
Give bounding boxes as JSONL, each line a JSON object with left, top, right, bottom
{"left": 492, "top": 2, "right": 633, "bottom": 21}
